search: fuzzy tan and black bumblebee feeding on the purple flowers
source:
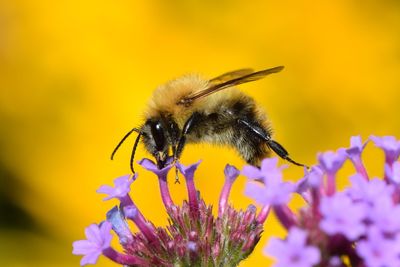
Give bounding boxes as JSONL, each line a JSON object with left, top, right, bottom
{"left": 111, "top": 66, "right": 304, "bottom": 172}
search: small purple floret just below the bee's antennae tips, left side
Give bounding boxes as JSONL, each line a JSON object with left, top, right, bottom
{"left": 96, "top": 174, "right": 137, "bottom": 200}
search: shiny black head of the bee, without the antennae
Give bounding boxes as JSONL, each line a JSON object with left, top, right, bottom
{"left": 142, "top": 118, "right": 169, "bottom": 168}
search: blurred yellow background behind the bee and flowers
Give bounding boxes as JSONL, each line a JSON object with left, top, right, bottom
{"left": 0, "top": 0, "right": 400, "bottom": 267}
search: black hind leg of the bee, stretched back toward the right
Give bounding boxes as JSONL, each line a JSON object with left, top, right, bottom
{"left": 238, "top": 119, "right": 308, "bottom": 168}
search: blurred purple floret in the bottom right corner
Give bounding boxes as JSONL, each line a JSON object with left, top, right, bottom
{"left": 356, "top": 227, "right": 400, "bottom": 267}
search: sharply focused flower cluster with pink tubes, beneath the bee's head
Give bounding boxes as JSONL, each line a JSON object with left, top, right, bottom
{"left": 73, "top": 159, "right": 269, "bottom": 266}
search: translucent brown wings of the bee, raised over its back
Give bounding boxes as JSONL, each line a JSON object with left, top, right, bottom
{"left": 177, "top": 66, "right": 283, "bottom": 105}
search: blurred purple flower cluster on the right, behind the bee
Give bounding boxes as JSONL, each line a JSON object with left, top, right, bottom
{"left": 243, "top": 136, "right": 400, "bottom": 267}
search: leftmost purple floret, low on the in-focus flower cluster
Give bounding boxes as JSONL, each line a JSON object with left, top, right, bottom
{"left": 72, "top": 221, "right": 112, "bottom": 266}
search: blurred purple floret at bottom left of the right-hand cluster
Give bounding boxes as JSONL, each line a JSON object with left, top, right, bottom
{"left": 265, "top": 227, "right": 321, "bottom": 267}
